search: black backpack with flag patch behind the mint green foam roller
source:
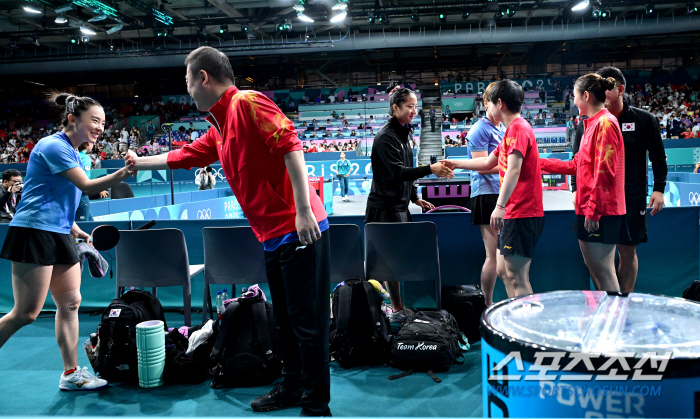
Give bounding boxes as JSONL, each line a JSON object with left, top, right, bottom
{"left": 92, "top": 289, "right": 168, "bottom": 381}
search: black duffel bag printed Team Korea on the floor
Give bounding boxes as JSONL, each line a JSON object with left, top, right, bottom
{"left": 389, "top": 310, "right": 466, "bottom": 383}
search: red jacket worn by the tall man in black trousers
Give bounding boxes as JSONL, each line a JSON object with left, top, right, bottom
{"left": 168, "top": 86, "right": 327, "bottom": 242}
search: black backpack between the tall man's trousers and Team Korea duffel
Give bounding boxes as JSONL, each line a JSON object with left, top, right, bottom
{"left": 329, "top": 279, "right": 389, "bottom": 368}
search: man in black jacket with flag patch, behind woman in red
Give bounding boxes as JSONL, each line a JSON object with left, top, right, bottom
{"left": 571, "top": 67, "right": 668, "bottom": 292}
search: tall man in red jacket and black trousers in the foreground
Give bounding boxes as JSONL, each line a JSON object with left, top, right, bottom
{"left": 126, "top": 47, "right": 331, "bottom": 416}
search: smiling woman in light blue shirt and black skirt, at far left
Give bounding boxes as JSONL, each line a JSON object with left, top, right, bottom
{"left": 0, "top": 93, "right": 135, "bottom": 390}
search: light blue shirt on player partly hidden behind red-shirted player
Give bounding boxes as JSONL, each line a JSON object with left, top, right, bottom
{"left": 467, "top": 117, "right": 505, "bottom": 197}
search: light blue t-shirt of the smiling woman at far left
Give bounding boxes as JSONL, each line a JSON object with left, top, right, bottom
{"left": 10, "top": 132, "right": 82, "bottom": 234}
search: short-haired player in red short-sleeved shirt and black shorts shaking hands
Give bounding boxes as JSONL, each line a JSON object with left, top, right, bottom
{"left": 443, "top": 80, "right": 544, "bottom": 297}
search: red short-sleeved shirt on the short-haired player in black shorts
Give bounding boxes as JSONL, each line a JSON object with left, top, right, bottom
{"left": 494, "top": 117, "right": 544, "bottom": 219}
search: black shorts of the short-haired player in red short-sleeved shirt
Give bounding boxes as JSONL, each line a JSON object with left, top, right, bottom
{"left": 498, "top": 217, "right": 544, "bottom": 259}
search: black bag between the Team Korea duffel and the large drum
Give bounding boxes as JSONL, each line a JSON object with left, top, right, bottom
{"left": 442, "top": 285, "right": 486, "bottom": 343}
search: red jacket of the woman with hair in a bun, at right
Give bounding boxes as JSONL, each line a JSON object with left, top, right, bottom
{"left": 540, "top": 109, "right": 626, "bottom": 221}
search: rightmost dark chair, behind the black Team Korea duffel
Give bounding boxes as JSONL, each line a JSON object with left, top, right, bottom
{"left": 365, "top": 222, "right": 442, "bottom": 308}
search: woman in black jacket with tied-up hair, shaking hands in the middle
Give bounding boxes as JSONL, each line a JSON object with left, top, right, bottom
{"left": 365, "top": 88, "right": 454, "bottom": 323}
